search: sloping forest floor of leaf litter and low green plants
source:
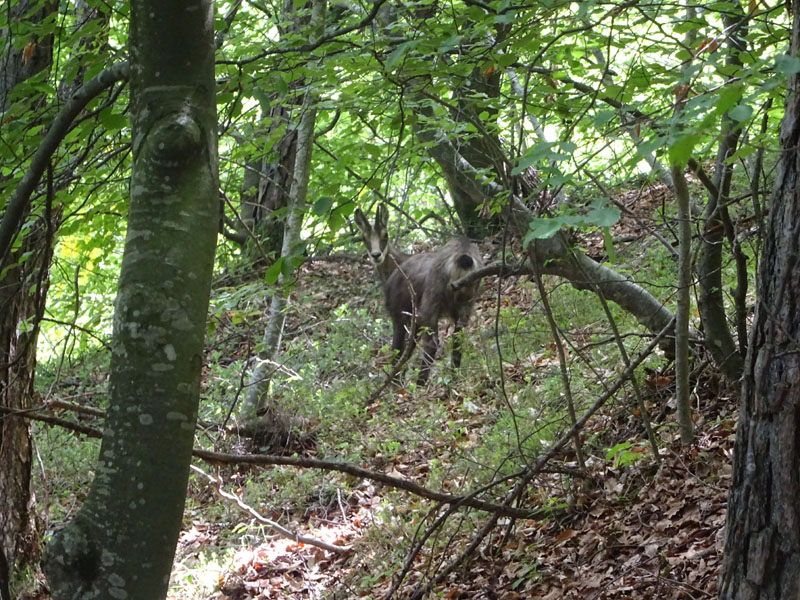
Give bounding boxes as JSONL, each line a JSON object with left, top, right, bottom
{"left": 26, "top": 183, "right": 736, "bottom": 600}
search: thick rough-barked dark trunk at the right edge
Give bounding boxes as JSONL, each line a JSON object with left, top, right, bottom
{"left": 719, "top": 3, "right": 800, "bottom": 600}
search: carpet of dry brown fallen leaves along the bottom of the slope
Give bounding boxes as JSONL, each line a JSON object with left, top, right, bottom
{"left": 175, "top": 386, "right": 735, "bottom": 600}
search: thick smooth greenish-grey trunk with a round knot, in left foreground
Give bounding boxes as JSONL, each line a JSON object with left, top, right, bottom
{"left": 43, "top": 0, "right": 219, "bottom": 600}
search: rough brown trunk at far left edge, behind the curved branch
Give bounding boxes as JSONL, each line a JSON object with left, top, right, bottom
{"left": 0, "top": 1, "right": 57, "bottom": 571}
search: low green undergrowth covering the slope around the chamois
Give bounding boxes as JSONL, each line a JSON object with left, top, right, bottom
{"left": 29, "top": 211, "right": 727, "bottom": 598}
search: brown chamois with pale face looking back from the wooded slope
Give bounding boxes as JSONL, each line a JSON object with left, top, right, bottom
{"left": 355, "top": 204, "right": 483, "bottom": 385}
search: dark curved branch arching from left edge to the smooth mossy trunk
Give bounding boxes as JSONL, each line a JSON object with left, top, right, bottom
{"left": 0, "top": 62, "right": 130, "bottom": 257}
